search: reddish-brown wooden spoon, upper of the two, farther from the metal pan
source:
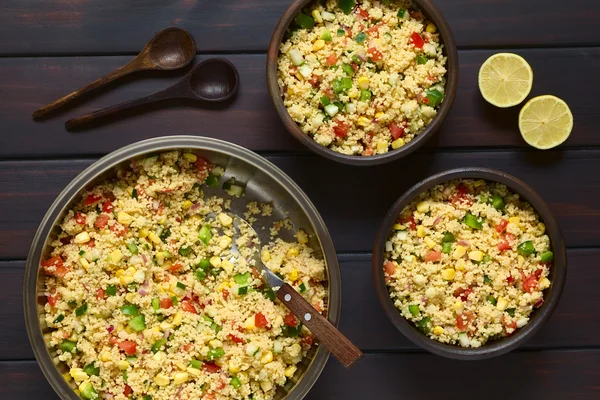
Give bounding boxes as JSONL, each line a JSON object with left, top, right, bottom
{"left": 33, "top": 27, "right": 196, "bottom": 120}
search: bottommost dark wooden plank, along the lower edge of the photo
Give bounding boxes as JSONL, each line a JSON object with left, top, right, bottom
{"left": 0, "top": 350, "right": 600, "bottom": 400}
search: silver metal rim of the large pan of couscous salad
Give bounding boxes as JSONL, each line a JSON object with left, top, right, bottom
{"left": 23, "top": 135, "right": 342, "bottom": 400}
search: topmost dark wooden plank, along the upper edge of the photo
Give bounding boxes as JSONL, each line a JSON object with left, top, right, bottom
{"left": 0, "top": 0, "right": 600, "bottom": 55}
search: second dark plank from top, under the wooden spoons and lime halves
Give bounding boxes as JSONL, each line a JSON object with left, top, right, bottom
{"left": 0, "top": 47, "right": 600, "bottom": 158}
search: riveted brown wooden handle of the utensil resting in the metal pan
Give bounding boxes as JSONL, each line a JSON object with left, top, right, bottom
{"left": 277, "top": 283, "right": 363, "bottom": 368}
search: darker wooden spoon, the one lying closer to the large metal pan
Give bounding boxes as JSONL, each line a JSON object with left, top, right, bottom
{"left": 65, "top": 58, "right": 240, "bottom": 130}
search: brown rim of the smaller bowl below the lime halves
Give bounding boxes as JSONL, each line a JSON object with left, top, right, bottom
{"left": 372, "top": 167, "right": 567, "bottom": 360}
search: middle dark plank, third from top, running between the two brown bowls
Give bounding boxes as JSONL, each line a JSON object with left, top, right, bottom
{"left": 0, "top": 150, "right": 600, "bottom": 259}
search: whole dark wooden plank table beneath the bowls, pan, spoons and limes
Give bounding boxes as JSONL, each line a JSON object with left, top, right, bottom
{"left": 0, "top": 0, "right": 600, "bottom": 400}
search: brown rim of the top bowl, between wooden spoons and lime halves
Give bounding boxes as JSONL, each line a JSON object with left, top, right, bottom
{"left": 267, "top": 0, "right": 458, "bottom": 165}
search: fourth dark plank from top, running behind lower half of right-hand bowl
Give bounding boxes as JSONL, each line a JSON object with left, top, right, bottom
{"left": 0, "top": 249, "right": 600, "bottom": 360}
